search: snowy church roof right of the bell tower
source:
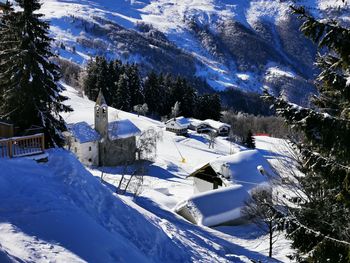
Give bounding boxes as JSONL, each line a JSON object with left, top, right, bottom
{"left": 108, "top": 119, "right": 141, "bottom": 140}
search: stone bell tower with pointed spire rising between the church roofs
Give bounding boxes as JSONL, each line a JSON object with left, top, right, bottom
{"left": 95, "top": 90, "right": 108, "bottom": 138}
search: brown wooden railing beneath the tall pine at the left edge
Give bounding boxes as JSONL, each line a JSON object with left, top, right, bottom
{"left": 0, "top": 133, "right": 45, "bottom": 158}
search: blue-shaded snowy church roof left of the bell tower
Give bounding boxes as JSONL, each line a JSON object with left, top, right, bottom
{"left": 67, "top": 121, "right": 100, "bottom": 143}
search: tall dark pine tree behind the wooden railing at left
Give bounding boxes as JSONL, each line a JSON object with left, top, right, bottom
{"left": 0, "top": 0, "right": 71, "bottom": 146}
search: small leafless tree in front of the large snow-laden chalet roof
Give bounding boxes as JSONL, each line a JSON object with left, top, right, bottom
{"left": 242, "top": 188, "right": 284, "bottom": 257}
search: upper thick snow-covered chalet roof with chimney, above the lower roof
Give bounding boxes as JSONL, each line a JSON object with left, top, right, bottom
{"left": 210, "top": 150, "right": 274, "bottom": 186}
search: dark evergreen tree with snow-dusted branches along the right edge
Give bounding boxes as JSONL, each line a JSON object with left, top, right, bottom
{"left": 265, "top": 5, "right": 350, "bottom": 262}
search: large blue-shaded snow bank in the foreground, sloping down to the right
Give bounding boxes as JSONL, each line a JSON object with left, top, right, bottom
{"left": 0, "top": 150, "right": 274, "bottom": 262}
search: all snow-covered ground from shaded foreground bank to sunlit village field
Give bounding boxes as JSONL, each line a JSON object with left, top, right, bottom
{"left": 0, "top": 84, "right": 298, "bottom": 262}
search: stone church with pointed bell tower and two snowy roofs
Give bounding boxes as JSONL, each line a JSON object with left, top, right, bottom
{"left": 65, "top": 91, "right": 141, "bottom": 166}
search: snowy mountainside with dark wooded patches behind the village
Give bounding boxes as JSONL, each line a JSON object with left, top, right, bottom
{"left": 37, "top": 0, "right": 349, "bottom": 104}
